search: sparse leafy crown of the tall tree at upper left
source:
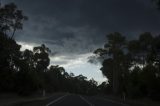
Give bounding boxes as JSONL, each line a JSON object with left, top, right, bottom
{"left": 0, "top": 3, "right": 28, "bottom": 38}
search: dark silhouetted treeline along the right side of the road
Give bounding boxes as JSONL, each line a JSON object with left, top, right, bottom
{"left": 94, "top": 32, "right": 160, "bottom": 100}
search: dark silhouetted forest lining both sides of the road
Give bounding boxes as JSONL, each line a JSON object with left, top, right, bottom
{"left": 0, "top": 3, "right": 160, "bottom": 100}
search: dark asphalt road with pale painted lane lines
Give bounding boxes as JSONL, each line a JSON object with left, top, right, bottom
{"left": 13, "top": 94, "right": 129, "bottom": 106}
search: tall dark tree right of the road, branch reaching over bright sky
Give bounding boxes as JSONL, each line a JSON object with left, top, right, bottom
{"left": 94, "top": 32, "right": 125, "bottom": 94}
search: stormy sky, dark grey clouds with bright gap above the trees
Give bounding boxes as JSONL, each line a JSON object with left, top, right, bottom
{"left": 1, "top": 0, "right": 160, "bottom": 82}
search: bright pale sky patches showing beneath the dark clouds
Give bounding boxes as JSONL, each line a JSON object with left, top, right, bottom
{"left": 18, "top": 42, "right": 107, "bottom": 83}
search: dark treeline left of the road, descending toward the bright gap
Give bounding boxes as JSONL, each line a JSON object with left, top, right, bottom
{"left": 0, "top": 3, "right": 98, "bottom": 96}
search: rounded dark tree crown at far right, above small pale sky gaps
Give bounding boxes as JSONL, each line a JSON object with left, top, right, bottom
{"left": 128, "top": 32, "right": 154, "bottom": 67}
